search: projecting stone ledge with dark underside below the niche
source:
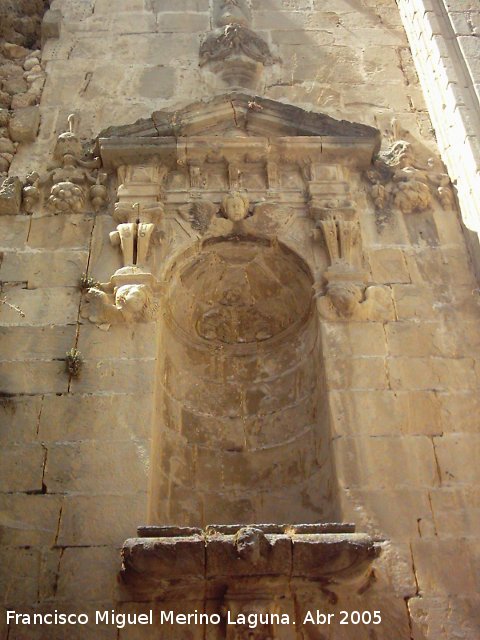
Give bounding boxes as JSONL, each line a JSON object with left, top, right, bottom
{"left": 120, "top": 524, "right": 380, "bottom": 601}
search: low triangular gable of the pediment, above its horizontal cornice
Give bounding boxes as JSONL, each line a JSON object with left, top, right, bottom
{"left": 99, "top": 93, "right": 379, "bottom": 141}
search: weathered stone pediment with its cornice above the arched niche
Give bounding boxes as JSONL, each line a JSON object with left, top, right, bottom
{"left": 98, "top": 93, "right": 380, "bottom": 168}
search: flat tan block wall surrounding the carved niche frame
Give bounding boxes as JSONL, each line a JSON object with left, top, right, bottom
{"left": 0, "top": 0, "right": 480, "bottom": 640}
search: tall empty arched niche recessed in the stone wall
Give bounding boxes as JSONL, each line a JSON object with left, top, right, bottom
{"left": 149, "top": 236, "right": 338, "bottom": 526}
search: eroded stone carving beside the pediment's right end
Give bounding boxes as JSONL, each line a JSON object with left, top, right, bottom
{"left": 366, "top": 140, "right": 453, "bottom": 214}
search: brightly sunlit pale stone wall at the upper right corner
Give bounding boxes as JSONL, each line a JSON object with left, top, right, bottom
{"left": 399, "top": 0, "right": 480, "bottom": 272}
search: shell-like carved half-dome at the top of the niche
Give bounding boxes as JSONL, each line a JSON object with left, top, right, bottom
{"left": 169, "top": 237, "right": 311, "bottom": 345}
